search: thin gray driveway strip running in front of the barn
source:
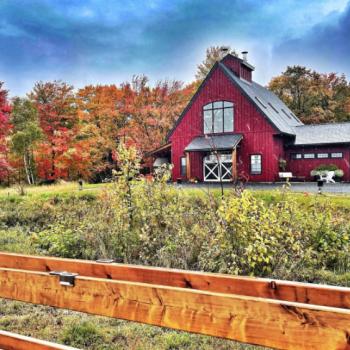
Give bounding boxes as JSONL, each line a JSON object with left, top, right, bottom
{"left": 176, "top": 182, "right": 350, "bottom": 194}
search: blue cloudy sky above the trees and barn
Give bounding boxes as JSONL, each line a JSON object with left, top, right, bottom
{"left": 0, "top": 0, "right": 350, "bottom": 96}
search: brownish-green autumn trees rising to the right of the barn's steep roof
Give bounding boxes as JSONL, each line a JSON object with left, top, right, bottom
{"left": 268, "top": 66, "right": 350, "bottom": 124}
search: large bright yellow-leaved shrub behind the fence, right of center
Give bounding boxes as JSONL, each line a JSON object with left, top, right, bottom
{"left": 200, "top": 191, "right": 304, "bottom": 275}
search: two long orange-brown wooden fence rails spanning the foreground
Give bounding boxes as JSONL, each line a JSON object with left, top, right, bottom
{"left": 0, "top": 253, "right": 350, "bottom": 350}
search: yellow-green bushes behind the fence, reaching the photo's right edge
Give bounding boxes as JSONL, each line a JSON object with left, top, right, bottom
{"left": 200, "top": 191, "right": 350, "bottom": 277}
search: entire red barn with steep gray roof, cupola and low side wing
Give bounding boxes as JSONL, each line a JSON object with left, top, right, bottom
{"left": 153, "top": 54, "right": 350, "bottom": 182}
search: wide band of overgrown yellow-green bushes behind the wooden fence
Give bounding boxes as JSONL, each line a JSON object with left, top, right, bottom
{"left": 27, "top": 142, "right": 350, "bottom": 278}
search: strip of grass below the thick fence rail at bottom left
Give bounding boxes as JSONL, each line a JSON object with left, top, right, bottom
{"left": 0, "top": 299, "right": 263, "bottom": 350}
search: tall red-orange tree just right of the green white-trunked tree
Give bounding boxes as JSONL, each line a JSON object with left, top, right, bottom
{"left": 28, "top": 81, "right": 78, "bottom": 180}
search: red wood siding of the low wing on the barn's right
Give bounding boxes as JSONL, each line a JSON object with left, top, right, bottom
{"left": 286, "top": 146, "right": 350, "bottom": 181}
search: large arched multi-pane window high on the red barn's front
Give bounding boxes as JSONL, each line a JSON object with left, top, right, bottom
{"left": 203, "top": 101, "right": 234, "bottom": 134}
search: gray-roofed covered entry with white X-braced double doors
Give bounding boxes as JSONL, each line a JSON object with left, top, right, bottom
{"left": 185, "top": 134, "right": 242, "bottom": 182}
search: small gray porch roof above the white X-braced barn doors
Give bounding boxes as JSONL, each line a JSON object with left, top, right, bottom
{"left": 185, "top": 134, "right": 242, "bottom": 152}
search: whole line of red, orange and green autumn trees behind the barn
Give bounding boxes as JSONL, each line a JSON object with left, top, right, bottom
{"left": 0, "top": 46, "right": 350, "bottom": 184}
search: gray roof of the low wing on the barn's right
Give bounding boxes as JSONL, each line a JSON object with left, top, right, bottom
{"left": 293, "top": 123, "right": 350, "bottom": 146}
